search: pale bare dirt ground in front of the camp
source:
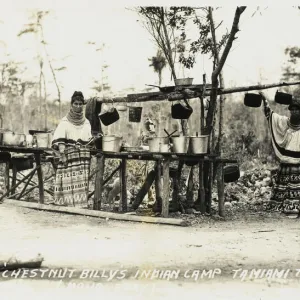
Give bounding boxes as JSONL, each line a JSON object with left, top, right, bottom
{"left": 0, "top": 202, "right": 300, "bottom": 300}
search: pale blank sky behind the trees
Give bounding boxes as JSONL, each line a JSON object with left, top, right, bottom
{"left": 0, "top": 0, "right": 300, "bottom": 100}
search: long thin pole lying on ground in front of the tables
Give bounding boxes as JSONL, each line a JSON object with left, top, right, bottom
{"left": 5, "top": 199, "right": 189, "bottom": 226}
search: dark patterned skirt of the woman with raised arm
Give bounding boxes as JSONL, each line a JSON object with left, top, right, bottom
{"left": 267, "top": 164, "right": 300, "bottom": 214}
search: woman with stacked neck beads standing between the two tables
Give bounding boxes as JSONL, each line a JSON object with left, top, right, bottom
{"left": 52, "top": 91, "right": 92, "bottom": 207}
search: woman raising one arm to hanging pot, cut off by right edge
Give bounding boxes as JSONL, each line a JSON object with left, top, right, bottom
{"left": 260, "top": 92, "right": 300, "bottom": 217}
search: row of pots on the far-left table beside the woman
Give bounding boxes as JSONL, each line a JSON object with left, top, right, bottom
{"left": 0, "top": 129, "right": 52, "bottom": 148}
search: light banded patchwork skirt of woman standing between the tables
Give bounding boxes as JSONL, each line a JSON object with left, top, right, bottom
{"left": 54, "top": 147, "right": 91, "bottom": 208}
